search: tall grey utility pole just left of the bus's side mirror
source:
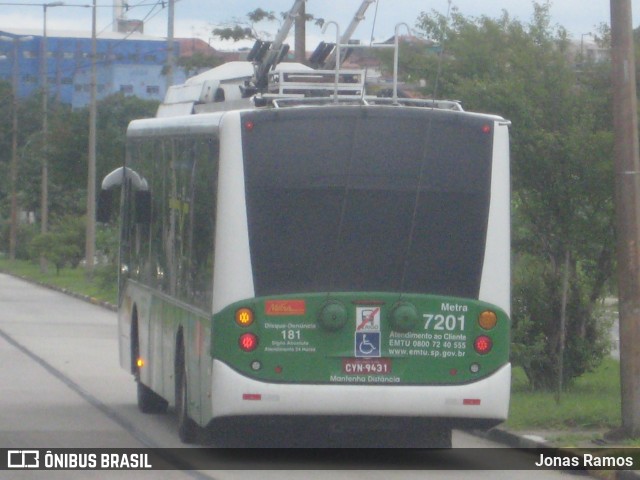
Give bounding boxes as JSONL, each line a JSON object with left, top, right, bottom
{"left": 85, "top": 0, "right": 98, "bottom": 278}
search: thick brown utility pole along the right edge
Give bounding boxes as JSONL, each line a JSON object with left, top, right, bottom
{"left": 610, "top": 0, "right": 640, "bottom": 437}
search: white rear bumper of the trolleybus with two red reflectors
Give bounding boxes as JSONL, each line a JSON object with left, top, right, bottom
{"left": 211, "top": 360, "right": 511, "bottom": 422}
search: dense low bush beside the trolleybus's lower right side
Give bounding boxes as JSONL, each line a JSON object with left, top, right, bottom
{"left": 512, "top": 255, "right": 610, "bottom": 390}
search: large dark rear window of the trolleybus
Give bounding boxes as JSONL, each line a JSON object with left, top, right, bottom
{"left": 243, "top": 107, "right": 492, "bottom": 298}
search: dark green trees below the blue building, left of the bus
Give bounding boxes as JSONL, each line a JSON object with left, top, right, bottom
{"left": 0, "top": 94, "right": 158, "bottom": 258}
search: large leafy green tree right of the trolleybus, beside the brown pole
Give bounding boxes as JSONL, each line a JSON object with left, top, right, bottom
{"left": 412, "top": 3, "right": 613, "bottom": 388}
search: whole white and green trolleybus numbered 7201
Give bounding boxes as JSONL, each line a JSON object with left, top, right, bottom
{"left": 103, "top": 52, "right": 511, "bottom": 446}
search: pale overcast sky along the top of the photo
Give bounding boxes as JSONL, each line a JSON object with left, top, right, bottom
{"left": 0, "top": 0, "right": 640, "bottom": 50}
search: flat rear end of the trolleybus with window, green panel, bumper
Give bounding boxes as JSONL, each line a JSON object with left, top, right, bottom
{"left": 211, "top": 106, "right": 510, "bottom": 446}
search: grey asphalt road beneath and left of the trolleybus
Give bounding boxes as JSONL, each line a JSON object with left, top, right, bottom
{"left": 0, "top": 274, "right": 567, "bottom": 480}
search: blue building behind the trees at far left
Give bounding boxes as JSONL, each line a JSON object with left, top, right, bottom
{"left": 0, "top": 28, "right": 184, "bottom": 108}
